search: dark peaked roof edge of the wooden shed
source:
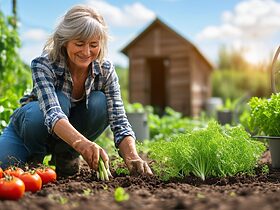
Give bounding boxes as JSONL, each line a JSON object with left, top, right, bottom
{"left": 121, "top": 17, "right": 213, "bottom": 69}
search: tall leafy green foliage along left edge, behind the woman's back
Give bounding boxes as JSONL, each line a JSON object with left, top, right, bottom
{"left": 0, "top": 11, "right": 31, "bottom": 132}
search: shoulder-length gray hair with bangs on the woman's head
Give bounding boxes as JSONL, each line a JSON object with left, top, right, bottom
{"left": 43, "top": 5, "right": 108, "bottom": 62}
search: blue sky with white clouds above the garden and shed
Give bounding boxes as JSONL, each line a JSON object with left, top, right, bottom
{"left": 0, "top": 0, "right": 280, "bottom": 67}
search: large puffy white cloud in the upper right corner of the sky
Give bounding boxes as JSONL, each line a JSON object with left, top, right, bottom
{"left": 196, "top": 0, "right": 280, "bottom": 62}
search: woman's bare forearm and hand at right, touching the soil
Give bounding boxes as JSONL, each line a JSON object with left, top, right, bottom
{"left": 119, "top": 136, "right": 153, "bottom": 175}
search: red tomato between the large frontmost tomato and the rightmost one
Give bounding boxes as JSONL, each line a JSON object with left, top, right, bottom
{"left": 19, "top": 171, "right": 42, "bottom": 193}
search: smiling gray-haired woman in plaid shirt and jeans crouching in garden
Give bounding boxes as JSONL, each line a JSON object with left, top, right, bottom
{"left": 0, "top": 5, "right": 152, "bottom": 175}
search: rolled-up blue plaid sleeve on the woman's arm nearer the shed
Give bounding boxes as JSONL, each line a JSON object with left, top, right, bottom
{"left": 102, "top": 62, "right": 136, "bottom": 147}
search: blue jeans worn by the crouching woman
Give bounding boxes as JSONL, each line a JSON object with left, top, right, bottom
{"left": 0, "top": 91, "right": 108, "bottom": 168}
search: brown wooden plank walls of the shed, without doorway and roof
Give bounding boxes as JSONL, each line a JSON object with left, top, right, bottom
{"left": 128, "top": 23, "right": 209, "bottom": 116}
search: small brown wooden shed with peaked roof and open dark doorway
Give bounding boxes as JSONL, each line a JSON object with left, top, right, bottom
{"left": 122, "top": 18, "right": 213, "bottom": 116}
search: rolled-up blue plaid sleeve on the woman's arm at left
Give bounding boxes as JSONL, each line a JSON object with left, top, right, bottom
{"left": 31, "top": 57, "right": 68, "bottom": 133}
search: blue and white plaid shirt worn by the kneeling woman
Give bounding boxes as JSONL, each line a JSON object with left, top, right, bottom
{"left": 20, "top": 55, "right": 135, "bottom": 147}
